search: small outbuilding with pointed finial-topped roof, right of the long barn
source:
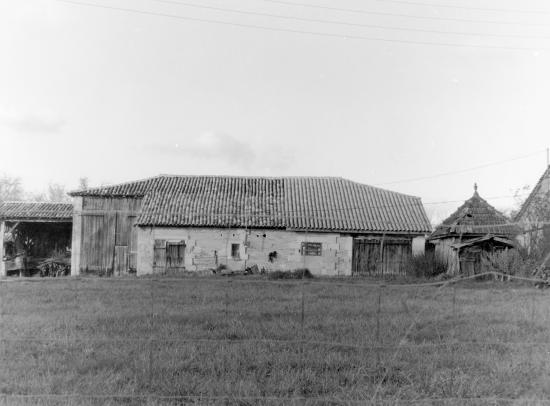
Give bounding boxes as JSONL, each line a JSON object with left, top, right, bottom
{"left": 428, "top": 185, "right": 517, "bottom": 275}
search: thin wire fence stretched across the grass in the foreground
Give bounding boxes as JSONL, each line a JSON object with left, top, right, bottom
{"left": 0, "top": 272, "right": 550, "bottom": 405}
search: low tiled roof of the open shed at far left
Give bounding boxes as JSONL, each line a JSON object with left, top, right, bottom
{"left": 0, "top": 202, "right": 73, "bottom": 221}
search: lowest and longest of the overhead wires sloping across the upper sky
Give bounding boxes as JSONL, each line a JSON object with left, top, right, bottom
{"left": 54, "top": 0, "right": 550, "bottom": 51}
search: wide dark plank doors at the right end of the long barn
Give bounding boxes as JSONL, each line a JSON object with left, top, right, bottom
{"left": 352, "top": 237, "right": 412, "bottom": 276}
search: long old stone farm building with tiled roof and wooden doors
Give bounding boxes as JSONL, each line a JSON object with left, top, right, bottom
{"left": 71, "top": 175, "right": 431, "bottom": 275}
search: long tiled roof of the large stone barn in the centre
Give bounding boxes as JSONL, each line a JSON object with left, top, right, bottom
{"left": 73, "top": 175, "right": 431, "bottom": 233}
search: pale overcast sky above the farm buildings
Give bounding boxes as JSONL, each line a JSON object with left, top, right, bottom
{"left": 0, "top": 0, "right": 550, "bottom": 221}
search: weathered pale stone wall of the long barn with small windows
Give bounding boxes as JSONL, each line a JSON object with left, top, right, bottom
{"left": 137, "top": 227, "right": 352, "bottom": 275}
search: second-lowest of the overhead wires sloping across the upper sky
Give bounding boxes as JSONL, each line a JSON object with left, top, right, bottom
{"left": 150, "top": 0, "right": 550, "bottom": 39}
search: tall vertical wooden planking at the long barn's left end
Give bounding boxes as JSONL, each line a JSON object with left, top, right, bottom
{"left": 77, "top": 197, "right": 141, "bottom": 275}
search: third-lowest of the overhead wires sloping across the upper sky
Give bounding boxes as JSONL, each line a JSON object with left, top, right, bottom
{"left": 261, "top": 0, "right": 550, "bottom": 27}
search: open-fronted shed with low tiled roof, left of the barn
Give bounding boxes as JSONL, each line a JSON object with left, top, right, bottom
{"left": 0, "top": 202, "right": 73, "bottom": 276}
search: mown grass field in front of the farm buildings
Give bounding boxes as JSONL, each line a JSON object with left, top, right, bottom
{"left": 0, "top": 277, "right": 550, "bottom": 405}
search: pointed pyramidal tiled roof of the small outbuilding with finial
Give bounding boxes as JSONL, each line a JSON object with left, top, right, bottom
{"left": 430, "top": 190, "right": 517, "bottom": 239}
